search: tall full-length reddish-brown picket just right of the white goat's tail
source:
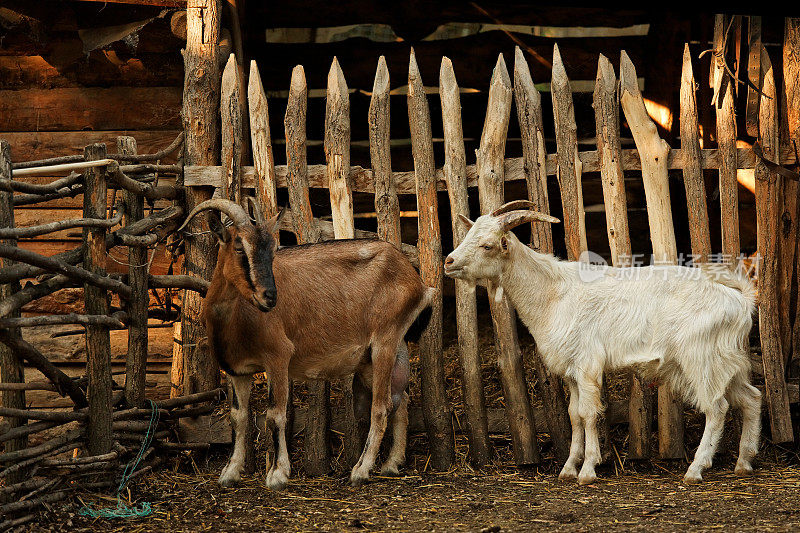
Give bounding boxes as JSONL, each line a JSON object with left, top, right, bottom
{"left": 755, "top": 47, "right": 794, "bottom": 443}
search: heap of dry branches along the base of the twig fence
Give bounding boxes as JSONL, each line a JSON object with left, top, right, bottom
{"left": 0, "top": 380, "right": 223, "bottom": 531}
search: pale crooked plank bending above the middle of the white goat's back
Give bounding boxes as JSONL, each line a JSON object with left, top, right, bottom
{"left": 620, "top": 48, "right": 685, "bottom": 459}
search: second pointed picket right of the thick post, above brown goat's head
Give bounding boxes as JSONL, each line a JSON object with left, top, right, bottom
{"left": 247, "top": 61, "right": 280, "bottom": 239}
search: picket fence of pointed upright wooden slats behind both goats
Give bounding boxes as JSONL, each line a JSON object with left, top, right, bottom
{"left": 178, "top": 16, "right": 797, "bottom": 471}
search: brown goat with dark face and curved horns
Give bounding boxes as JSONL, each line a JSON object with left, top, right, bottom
{"left": 179, "top": 200, "right": 435, "bottom": 489}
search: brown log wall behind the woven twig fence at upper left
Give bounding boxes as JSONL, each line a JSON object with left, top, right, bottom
{"left": 0, "top": 1, "right": 184, "bottom": 290}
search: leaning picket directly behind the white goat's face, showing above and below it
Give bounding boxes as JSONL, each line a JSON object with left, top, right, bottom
{"left": 475, "top": 54, "right": 541, "bottom": 465}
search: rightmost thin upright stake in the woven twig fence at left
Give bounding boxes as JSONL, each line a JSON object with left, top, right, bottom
{"left": 117, "top": 136, "right": 150, "bottom": 407}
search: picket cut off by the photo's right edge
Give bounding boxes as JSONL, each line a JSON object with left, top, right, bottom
{"left": 778, "top": 18, "right": 800, "bottom": 365}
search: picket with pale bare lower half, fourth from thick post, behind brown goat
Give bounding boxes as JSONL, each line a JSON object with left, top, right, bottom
{"left": 325, "top": 57, "right": 362, "bottom": 468}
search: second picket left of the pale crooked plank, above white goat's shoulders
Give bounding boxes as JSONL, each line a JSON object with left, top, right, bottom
{"left": 551, "top": 45, "right": 587, "bottom": 261}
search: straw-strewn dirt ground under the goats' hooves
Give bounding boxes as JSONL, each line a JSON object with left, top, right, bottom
{"left": 28, "top": 444, "right": 800, "bottom": 533}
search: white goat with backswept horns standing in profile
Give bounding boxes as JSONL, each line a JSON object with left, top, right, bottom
{"left": 445, "top": 201, "right": 761, "bottom": 484}
